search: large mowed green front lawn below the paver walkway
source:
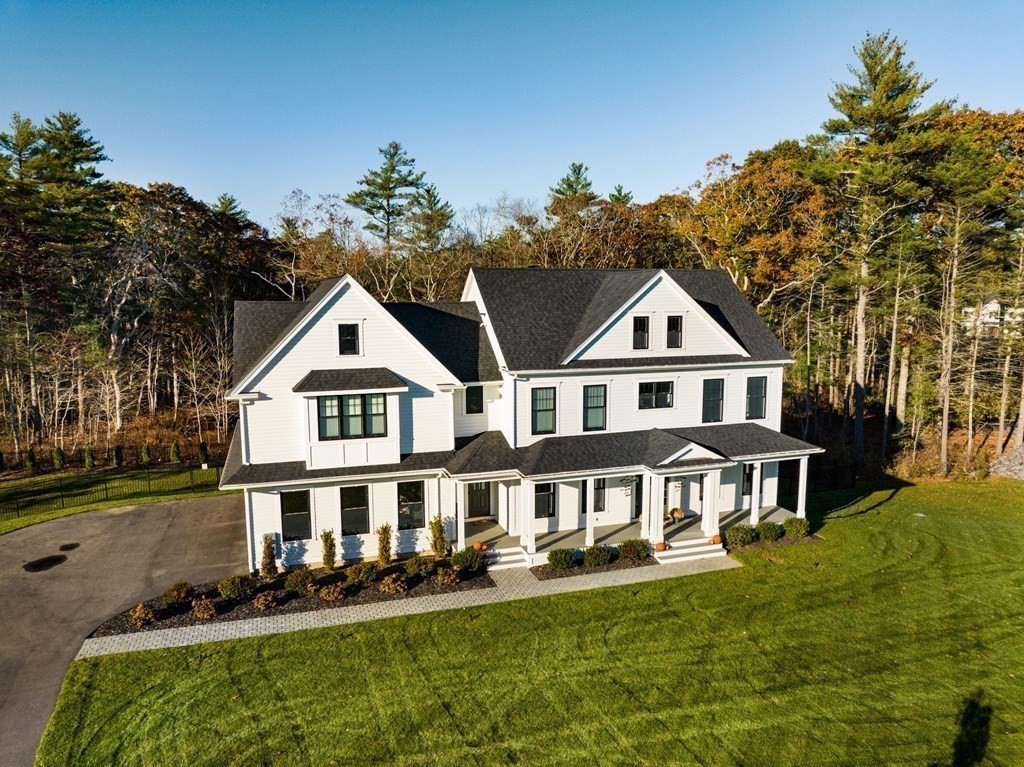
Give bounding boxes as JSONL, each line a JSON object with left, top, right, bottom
{"left": 37, "top": 480, "right": 1024, "bottom": 767}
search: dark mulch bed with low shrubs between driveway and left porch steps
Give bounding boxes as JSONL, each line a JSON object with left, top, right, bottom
{"left": 89, "top": 562, "right": 495, "bottom": 637}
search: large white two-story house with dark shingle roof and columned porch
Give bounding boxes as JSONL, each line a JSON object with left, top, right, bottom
{"left": 221, "top": 268, "right": 822, "bottom": 567}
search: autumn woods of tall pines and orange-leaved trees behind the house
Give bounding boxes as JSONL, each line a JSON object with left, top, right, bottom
{"left": 0, "top": 34, "right": 1024, "bottom": 474}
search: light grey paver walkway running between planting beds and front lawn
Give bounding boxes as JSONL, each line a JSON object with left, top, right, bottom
{"left": 78, "top": 557, "right": 742, "bottom": 658}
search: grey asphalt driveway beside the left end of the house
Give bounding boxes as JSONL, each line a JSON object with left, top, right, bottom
{"left": 0, "top": 494, "right": 246, "bottom": 767}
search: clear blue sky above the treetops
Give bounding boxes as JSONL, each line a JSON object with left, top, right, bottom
{"left": 0, "top": 0, "right": 1024, "bottom": 224}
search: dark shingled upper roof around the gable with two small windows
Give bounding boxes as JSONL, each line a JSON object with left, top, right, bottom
{"left": 473, "top": 267, "right": 790, "bottom": 371}
